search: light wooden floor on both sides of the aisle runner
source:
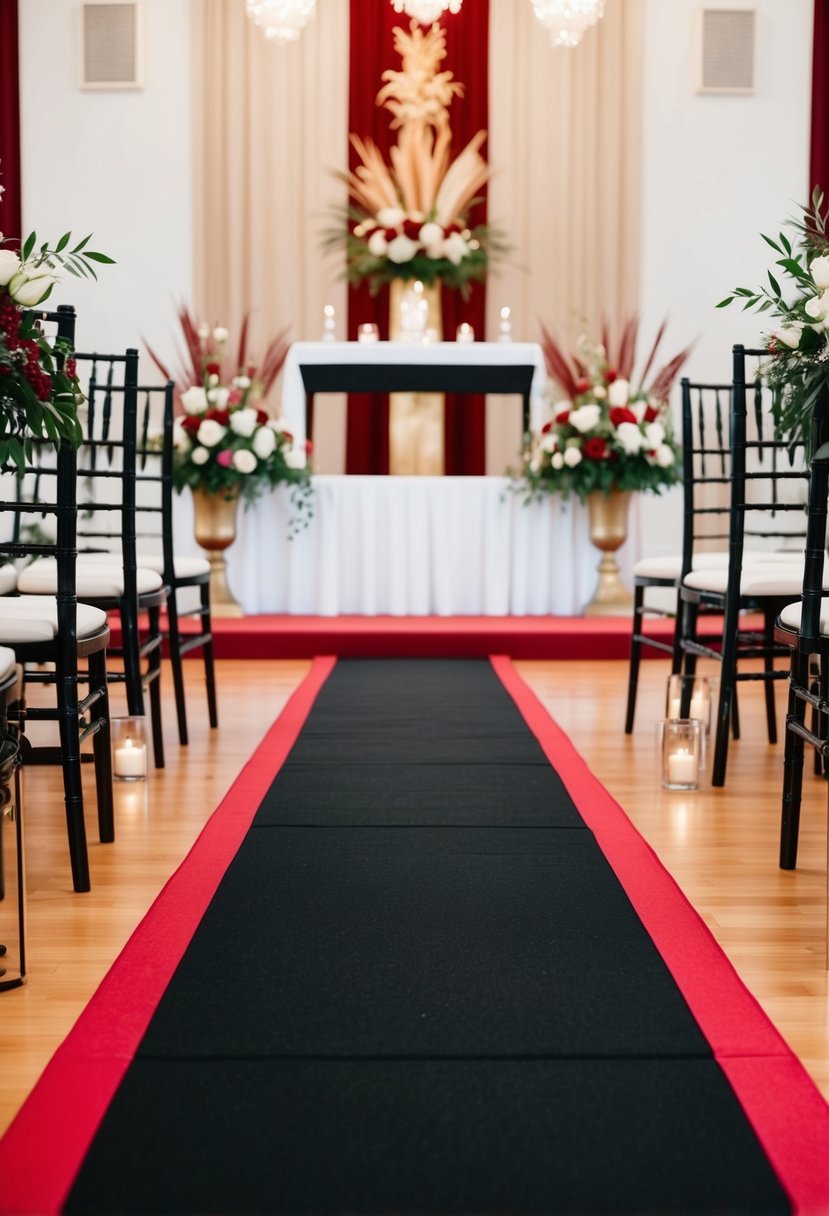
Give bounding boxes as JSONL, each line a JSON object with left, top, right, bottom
{"left": 0, "top": 660, "right": 829, "bottom": 1131}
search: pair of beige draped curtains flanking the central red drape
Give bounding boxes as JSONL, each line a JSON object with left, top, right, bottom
{"left": 193, "top": 0, "right": 643, "bottom": 473}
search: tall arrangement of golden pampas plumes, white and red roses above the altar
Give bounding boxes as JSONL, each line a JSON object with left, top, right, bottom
{"left": 327, "top": 21, "right": 503, "bottom": 294}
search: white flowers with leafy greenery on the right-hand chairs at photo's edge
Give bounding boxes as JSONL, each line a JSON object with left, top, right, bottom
{"left": 717, "top": 186, "right": 829, "bottom": 454}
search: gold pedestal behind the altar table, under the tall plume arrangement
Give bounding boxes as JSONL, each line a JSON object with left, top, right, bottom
{"left": 389, "top": 278, "right": 444, "bottom": 477}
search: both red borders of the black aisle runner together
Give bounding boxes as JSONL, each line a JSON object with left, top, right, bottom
{"left": 0, "top": 657, "right": 829, "bottom": 1216}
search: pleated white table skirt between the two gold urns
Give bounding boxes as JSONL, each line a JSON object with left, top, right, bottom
{"left": 175, "top": 475, "right": 639, "bottom": 617}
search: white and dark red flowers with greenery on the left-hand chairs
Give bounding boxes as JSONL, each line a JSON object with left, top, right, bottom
{"left": 0, "top": 207, "right": 112, "bottom": 469}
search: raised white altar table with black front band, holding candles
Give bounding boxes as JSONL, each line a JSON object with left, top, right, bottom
{"left": 282, "top": 342, "right": 546, "bottom": 440}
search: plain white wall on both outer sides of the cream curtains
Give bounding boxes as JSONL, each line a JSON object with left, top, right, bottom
{"left": 19, "top": 0, "right": 812, "bottom": 553}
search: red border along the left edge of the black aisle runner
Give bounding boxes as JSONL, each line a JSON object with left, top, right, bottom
{"left": 0, "top": 658, "right": 337, "bottom": 1216}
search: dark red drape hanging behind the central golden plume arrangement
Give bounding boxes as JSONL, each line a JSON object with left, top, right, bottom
{"left": 345, "top": 0, "right": 489, "bottom": 474}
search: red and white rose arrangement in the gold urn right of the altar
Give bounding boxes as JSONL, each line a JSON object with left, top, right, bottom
{"left": 519, "top": 319, "right": 689, "bottom": 502}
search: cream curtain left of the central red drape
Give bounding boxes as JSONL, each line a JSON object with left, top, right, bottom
{"left": 192, "top": 0, "right": 349, "bottom": 472}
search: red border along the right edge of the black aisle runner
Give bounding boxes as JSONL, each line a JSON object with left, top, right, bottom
{"left": 491, "top": 655, "right": 829, "bottom": 1216}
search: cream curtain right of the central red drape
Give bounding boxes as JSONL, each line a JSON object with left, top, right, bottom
{"left": 486, "top": 0, "right": 644, "bottom": 474}
